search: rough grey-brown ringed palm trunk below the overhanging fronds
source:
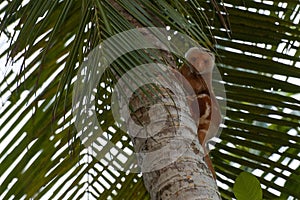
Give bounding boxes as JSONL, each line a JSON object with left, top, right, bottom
{"left": 129, "top": 83, "right": 221, "bottom": 200}
